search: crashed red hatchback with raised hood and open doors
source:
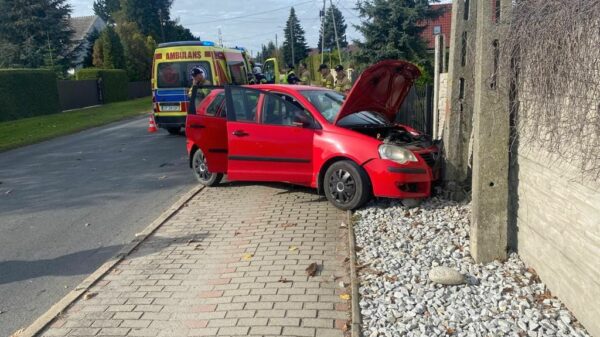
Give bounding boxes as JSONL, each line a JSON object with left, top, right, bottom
{"left": 186, "top": 61, "right": 439, "bottom": 209}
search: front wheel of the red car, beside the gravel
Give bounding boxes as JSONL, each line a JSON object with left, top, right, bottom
{"left": 323, "top": 160, "right": 371, "bottom": 210}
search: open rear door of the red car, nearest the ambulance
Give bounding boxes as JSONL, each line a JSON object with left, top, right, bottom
{"left": 186, "top": 91, "right": 227, "bottom": 173}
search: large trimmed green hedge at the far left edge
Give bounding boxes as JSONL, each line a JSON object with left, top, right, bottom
{"left": 0, "top": 69, "right": 61, "bottom": 122}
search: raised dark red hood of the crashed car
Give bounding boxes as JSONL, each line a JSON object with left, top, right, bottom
{"left": 335, "top": 60, "right": 421, "bottom": 123}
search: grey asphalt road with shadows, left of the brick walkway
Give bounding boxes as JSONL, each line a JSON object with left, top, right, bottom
{"left": 0, "top": 118, "right": 195, "bottom": 336}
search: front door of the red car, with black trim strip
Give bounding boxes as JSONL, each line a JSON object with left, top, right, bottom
{"left": 225, "top": 87, "right": 316, "bottom": 185}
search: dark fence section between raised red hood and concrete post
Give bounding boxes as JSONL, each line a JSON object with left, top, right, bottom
{"left": 396, "top": 85, "right": 433, "bottom": 135}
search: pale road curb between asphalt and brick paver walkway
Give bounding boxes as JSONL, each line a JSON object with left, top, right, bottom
{"left": 16, "top": 185, "right": 204, "bottom": 337}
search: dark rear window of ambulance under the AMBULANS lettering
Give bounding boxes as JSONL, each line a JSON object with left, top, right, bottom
{"left": 156, "top": 61, "right": 212, "bottom": 88}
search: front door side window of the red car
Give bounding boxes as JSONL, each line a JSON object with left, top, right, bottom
{"left": 262, "top": 94, "right": 313, "bottom": 126}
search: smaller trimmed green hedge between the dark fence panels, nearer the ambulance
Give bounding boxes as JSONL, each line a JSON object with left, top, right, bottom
{"left": 76, "top": 68, "right": 129, "bottom": 103}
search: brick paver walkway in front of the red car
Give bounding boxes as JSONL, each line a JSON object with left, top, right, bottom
{"left": 42, "top": 184, "right": 349, "bottom": 337}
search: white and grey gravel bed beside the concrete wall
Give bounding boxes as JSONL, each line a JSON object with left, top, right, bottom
{"left": 354, "top": 198, "right": 590, "bottom": 337}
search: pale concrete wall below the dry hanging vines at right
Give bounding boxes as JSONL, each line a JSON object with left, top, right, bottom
{"left": 511, "top": 146, "right": 600, "bottom": 336}
